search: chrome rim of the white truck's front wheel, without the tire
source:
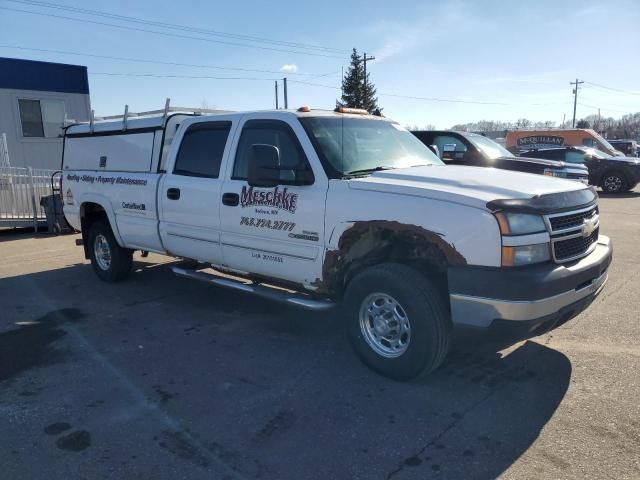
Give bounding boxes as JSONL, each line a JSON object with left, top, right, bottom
{"left": 359, "top": 293, "right": 411, "bottom": 358}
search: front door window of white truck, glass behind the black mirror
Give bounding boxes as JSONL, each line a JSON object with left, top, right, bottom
{"left": 231, "top": 120, "right": 311, "bottom": 181}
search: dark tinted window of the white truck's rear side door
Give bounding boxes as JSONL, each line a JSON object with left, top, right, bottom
{"left": 173, "top": 122, "right": 231, "bottom": 178}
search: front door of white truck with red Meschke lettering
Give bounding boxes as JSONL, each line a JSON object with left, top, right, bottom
{"left": 220, "top": 114, "right": 328, "bottom": 288}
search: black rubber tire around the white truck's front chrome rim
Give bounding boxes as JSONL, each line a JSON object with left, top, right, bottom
{"left": 344, "top": 263, "right": 451, "bottom": 380}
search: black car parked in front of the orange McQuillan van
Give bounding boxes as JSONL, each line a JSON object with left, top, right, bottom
{"left": 523, "top": 147, "right": 640, "bottom": 193}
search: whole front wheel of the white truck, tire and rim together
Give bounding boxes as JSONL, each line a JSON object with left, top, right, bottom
{"left": 345, "top": 263, "right": 451, "bottom": 380}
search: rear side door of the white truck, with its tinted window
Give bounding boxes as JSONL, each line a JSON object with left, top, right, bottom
{"left": 158, "top": 117, "right": 235, "bottom": 264}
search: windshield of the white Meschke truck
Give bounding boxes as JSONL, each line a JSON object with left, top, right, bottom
{"left": 300, "top": 116, "right": 444, "bottom": 175}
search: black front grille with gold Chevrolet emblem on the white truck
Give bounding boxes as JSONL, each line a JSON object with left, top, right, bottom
{"left": 545, "top": 205, "right": 600, "bottom": 263}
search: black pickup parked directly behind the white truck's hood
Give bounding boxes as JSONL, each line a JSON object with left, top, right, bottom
{"left": 411, "top": 130, "right": 588, "bottom": 184}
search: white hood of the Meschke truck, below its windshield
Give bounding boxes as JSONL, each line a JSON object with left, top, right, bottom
{"left": 349, "top": 165, "right": 588, "bottom": 209}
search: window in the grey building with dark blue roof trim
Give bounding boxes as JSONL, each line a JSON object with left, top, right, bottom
{"left": 18, "top": 98, "right": 65, "bottom": 138}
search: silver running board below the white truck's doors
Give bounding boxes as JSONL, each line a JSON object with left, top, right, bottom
{"left": 171, "top": 267, "right": 335, "bottom": 311}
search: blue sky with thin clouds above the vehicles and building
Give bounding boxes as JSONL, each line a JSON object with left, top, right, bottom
{"left": 0, "top": 0, "right": 640, "bottom": 128}
